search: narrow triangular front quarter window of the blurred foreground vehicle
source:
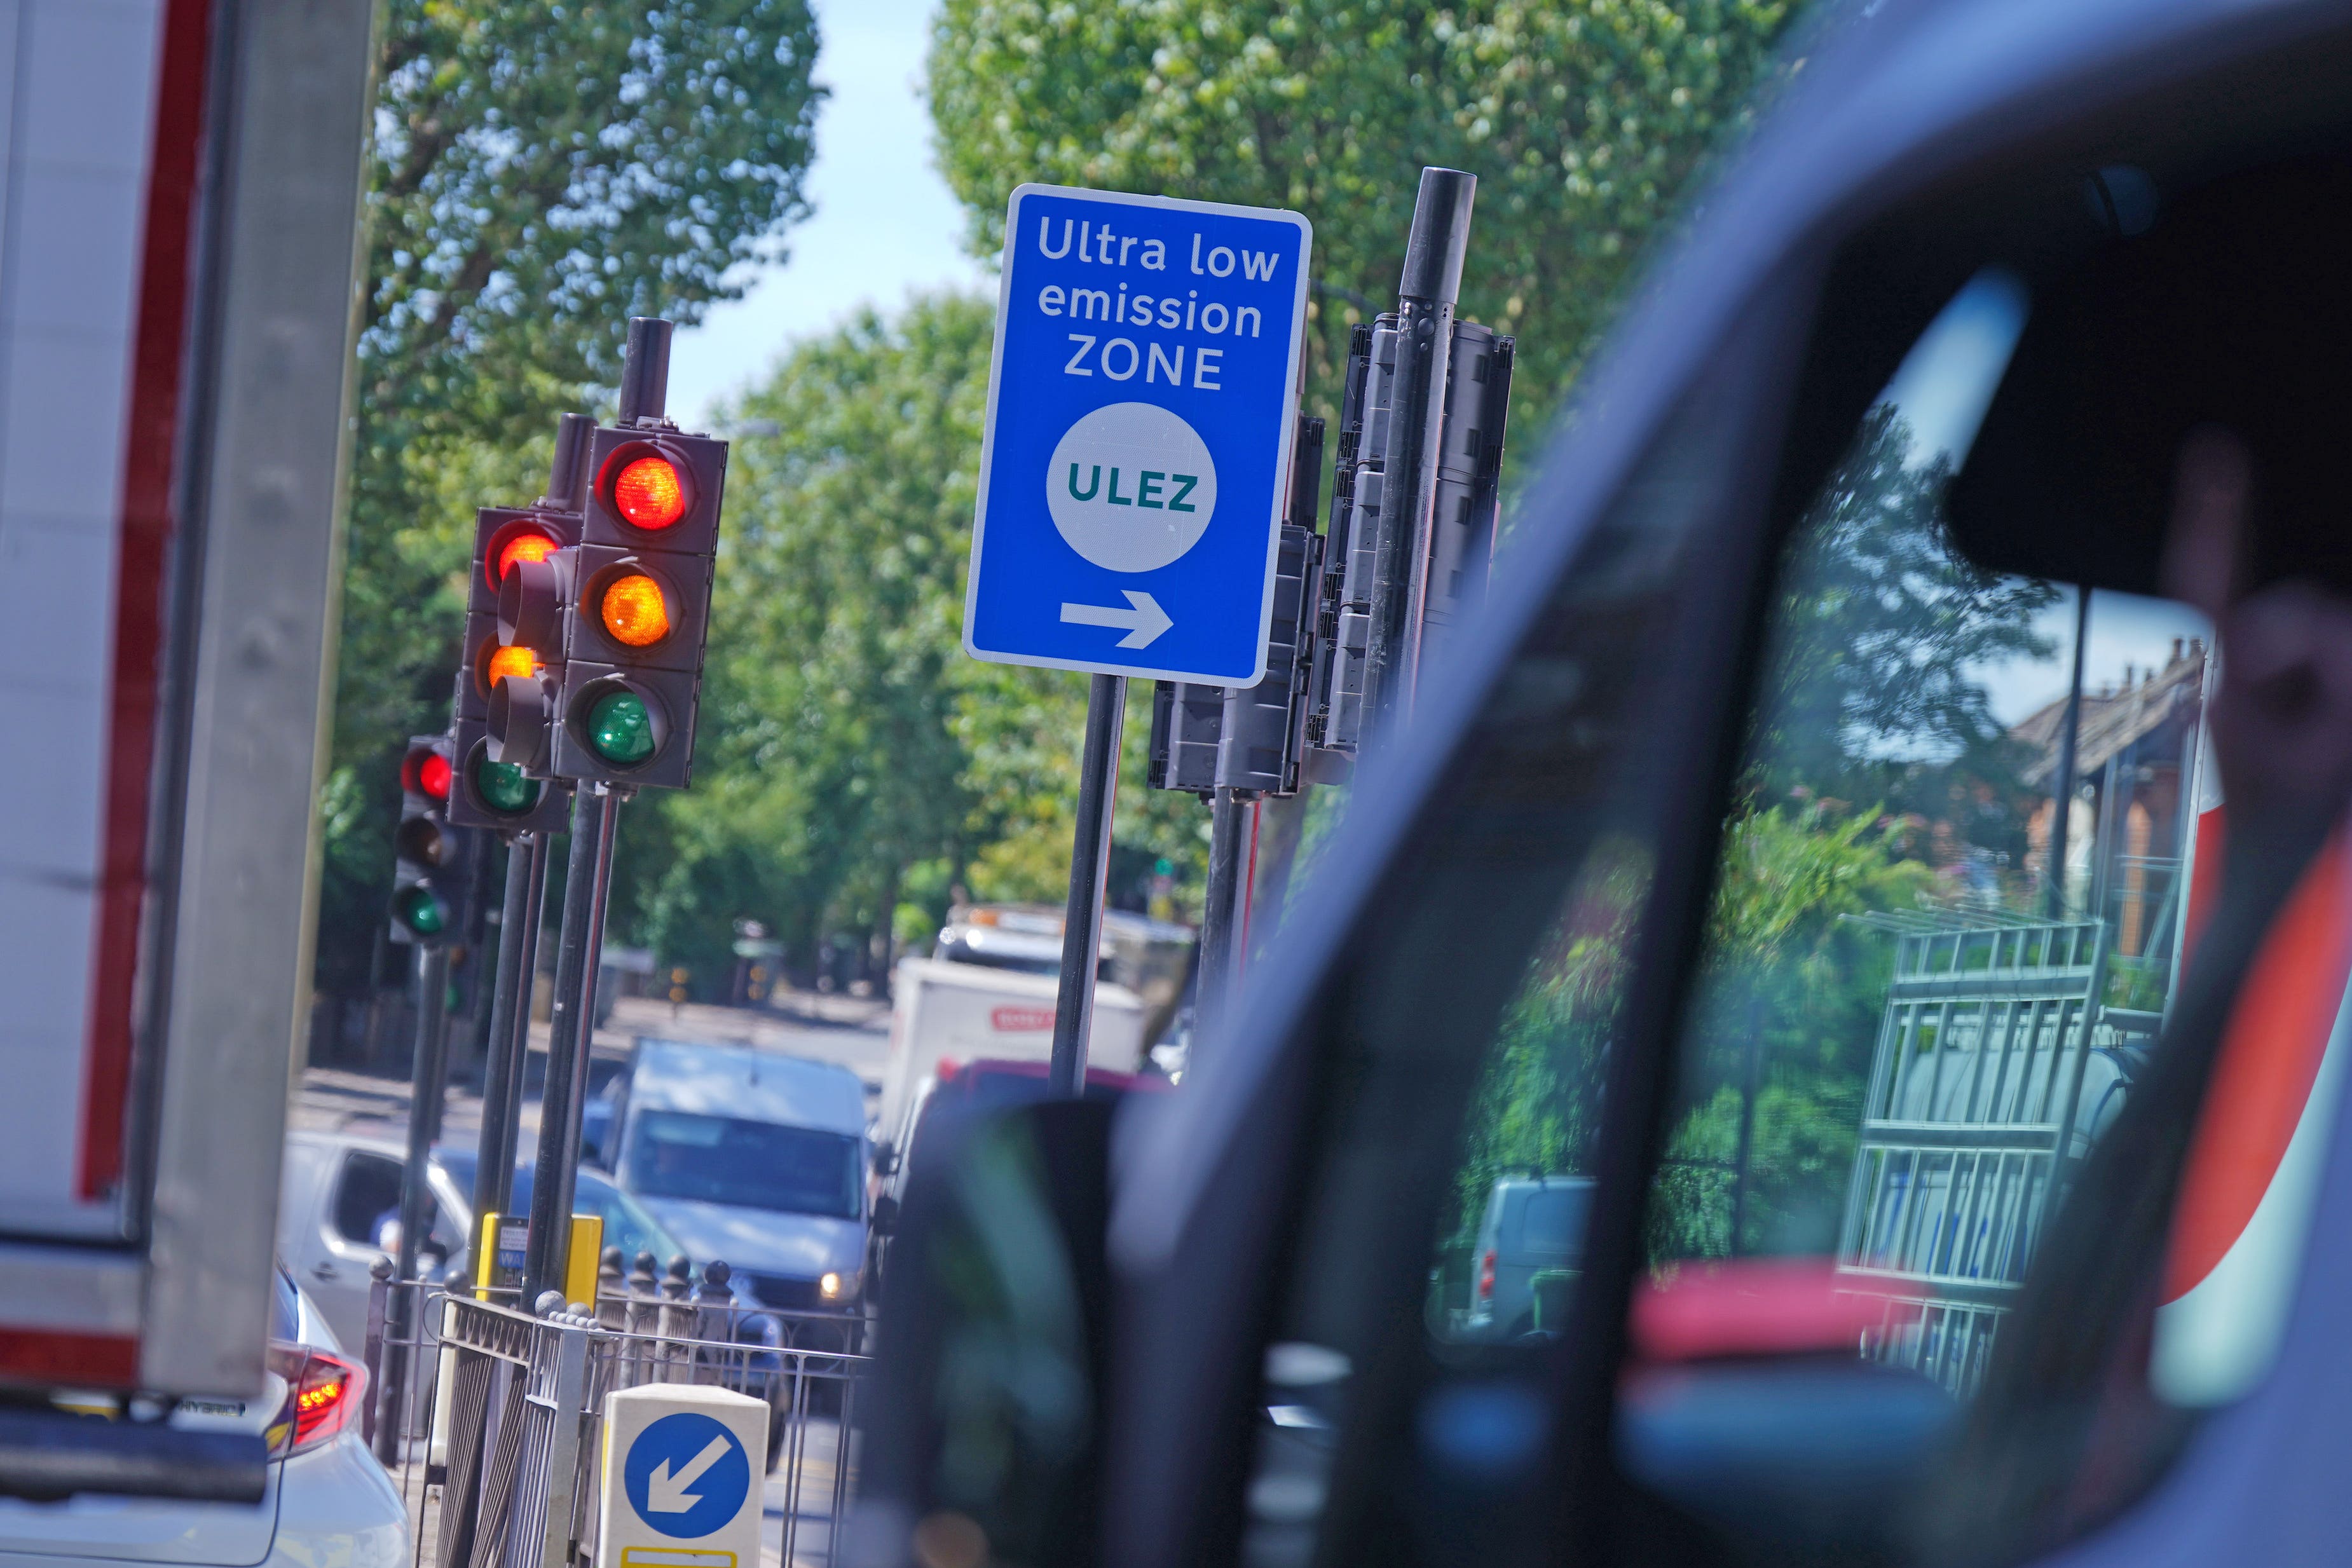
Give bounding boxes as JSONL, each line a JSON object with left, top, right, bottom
{"left": 1242, "top": 310, "right": 1785, "bottom": 1564}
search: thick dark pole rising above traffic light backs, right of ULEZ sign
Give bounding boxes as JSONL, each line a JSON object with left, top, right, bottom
{"left": 1364, "top": 169, "right": 1477, "bottom": 717}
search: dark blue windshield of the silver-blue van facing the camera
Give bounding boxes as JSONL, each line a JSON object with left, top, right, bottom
{"left": 628, "top": 1110, "right": 861, "bottom": 1220}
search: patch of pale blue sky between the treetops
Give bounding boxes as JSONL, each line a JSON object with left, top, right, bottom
{"left": 671, "top": 0, "right": 992, "bottom": 423}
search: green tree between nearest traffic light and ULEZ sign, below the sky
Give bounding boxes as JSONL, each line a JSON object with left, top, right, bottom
{"left": 616, "top": 294, "right": 1207, "bottom": 973}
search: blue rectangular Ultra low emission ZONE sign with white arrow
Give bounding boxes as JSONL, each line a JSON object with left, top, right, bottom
{"left": 964, "top": 186, "right": 1313, "bottom": 686}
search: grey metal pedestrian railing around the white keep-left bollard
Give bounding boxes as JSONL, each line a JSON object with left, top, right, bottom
{"left": 365, "top": 1253, "right": 873, "bottom": 1568}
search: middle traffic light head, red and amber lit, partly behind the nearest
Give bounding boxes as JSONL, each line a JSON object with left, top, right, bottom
{"left": 449, "top": 512, "right": 585, "bottom": 832}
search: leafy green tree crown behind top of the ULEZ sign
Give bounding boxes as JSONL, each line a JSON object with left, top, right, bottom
{"left": 929, "top": 0, "right": 1792, "bottom": 437}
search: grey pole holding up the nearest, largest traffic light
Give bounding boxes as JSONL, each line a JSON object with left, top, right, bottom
{"left": 522, "top": 783, "right": 621, "bottom": 1302}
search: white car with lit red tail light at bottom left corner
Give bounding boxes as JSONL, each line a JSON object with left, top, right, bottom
{"left": 0, "top": 1265, "right": 414, "bottom": 1568}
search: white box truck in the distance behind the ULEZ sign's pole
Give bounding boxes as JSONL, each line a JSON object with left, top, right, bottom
{"left": 875, "top": 959, "right": 1145, "bottom": 1161}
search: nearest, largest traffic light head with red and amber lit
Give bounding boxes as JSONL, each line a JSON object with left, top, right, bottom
{"left": 543, "top": 425, "right": 727, "bottom": 787}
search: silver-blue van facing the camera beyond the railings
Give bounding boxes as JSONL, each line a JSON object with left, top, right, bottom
{"left": 602, "top": 1039, "right": 868, "bottom": 1340}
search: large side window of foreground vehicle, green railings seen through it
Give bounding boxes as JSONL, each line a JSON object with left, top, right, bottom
{"left": 1618, "top": 273, "right": 2258, "bottom": 1554}
